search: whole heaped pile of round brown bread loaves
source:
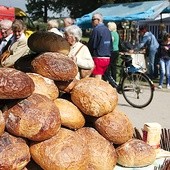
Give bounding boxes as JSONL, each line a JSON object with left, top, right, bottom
{"left": 0, "top": 33, "right": 156, "bottom": 170}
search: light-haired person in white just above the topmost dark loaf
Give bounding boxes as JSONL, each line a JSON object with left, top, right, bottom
{"left": 47, "top": 19, "right": 63, "bottom": 37}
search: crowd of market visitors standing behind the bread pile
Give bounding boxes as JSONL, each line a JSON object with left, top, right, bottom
{"left": 0, "top": 13, "right": 170, "bottom": 89}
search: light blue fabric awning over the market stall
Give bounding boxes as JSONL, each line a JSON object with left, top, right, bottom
{"left": 76, "top": 0, "right": 170, "bottom": 28}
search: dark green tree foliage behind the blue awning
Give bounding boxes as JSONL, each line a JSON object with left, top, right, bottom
{"left": 26, "top": 0, "right": 153, "bottom": 22}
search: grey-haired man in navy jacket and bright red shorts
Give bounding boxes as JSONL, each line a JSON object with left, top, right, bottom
{"left": 88, "top": 13, "right": 112, "bottom": 79}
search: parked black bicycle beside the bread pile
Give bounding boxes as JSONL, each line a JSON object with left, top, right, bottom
{"left": 103, "top": 53, "right": 154, "bottom": 108}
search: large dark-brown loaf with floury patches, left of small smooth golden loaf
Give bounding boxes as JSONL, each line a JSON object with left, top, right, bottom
{"left": 4, "top": 93, "right": 61, "bottom": 141}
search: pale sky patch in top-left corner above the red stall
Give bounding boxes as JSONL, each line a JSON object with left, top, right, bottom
{"left": 0, "top": 0, "right": 26, "bottom": 11}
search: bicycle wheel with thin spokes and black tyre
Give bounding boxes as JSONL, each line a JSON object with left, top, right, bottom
{"left": 122, "top": 72, "right": 154, "bottom": 108}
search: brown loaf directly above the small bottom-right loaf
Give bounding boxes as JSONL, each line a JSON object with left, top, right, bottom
{"left": 95, "top": 109, "right": 133, "bottom": 144}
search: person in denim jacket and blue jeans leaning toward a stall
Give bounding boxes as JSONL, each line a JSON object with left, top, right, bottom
{"left": 137, "top": 25, "right": 159, "bottom": 79}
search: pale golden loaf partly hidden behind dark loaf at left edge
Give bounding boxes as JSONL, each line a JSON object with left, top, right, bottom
{"left": 27, "top": 73, "right": 59, "bottom": 100}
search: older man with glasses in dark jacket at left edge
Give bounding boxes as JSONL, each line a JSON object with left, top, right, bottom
{"left": 0, "top": 19, "right": 13, "bottom": 54}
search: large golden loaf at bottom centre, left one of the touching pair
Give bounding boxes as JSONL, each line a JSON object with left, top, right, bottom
{"left": 30, "top": 128, "right": 89, "bottom": 170}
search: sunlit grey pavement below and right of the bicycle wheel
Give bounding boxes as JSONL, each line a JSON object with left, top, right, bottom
{"left": 117, "top": 87, "right": 170, "bottom": 130}
